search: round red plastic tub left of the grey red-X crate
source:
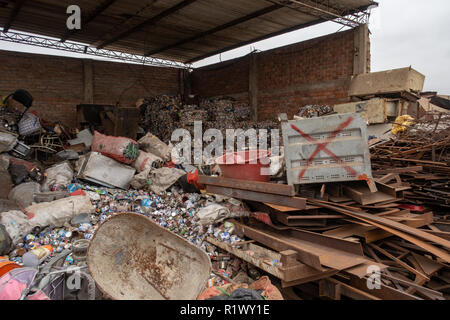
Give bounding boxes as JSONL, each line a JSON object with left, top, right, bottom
{"left": 216, "top": 150, "right": 270, "bottom": 182}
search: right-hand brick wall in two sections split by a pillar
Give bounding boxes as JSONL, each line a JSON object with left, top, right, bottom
{"left": 191, "top": 29, "right": 370, "bottom": 120}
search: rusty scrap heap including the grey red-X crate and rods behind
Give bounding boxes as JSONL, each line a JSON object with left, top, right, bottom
{"left": 199, "top": 114, "right": 450, "bottom": 300}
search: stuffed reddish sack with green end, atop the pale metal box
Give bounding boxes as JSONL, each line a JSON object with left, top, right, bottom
{"left": 91, "top": 131, "right": 139, "bottom": 164}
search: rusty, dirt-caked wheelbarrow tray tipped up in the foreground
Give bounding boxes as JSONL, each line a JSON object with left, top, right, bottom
{"left": 87, "top": 213, "right": 211, "bottom": 300}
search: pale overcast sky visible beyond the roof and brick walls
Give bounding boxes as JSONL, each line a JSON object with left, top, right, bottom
{"left": 0, "top": 0, "right": 450, "bottom": 95}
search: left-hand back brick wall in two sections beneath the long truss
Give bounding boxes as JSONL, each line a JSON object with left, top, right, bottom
{"left": 0, "top": 51, "right": 180, "bottom": 126}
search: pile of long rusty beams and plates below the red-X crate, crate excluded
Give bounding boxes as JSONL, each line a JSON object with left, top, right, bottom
{"left": 199, "top": 173, "right": 450, "bottom": 300}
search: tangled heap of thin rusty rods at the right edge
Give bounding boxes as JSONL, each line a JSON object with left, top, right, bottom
{"left": 371, "top": 114, "right": 450, "bottom": 212}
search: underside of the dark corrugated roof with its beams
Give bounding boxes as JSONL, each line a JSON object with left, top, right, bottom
{"left": 0, "top": 0, "right": 374, "bottom": 62}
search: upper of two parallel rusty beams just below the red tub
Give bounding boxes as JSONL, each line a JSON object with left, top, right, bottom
{"left": 198, "top": 175, "right": 295, "bottom": 196}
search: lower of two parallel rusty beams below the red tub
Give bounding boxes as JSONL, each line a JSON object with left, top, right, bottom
{"left": 206, "top": 185, "right": 306, "bottom": 209}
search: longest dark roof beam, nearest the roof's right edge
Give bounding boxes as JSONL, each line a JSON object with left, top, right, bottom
{"left": 145, "top": 4, "right": 283, "bottom": 57}
